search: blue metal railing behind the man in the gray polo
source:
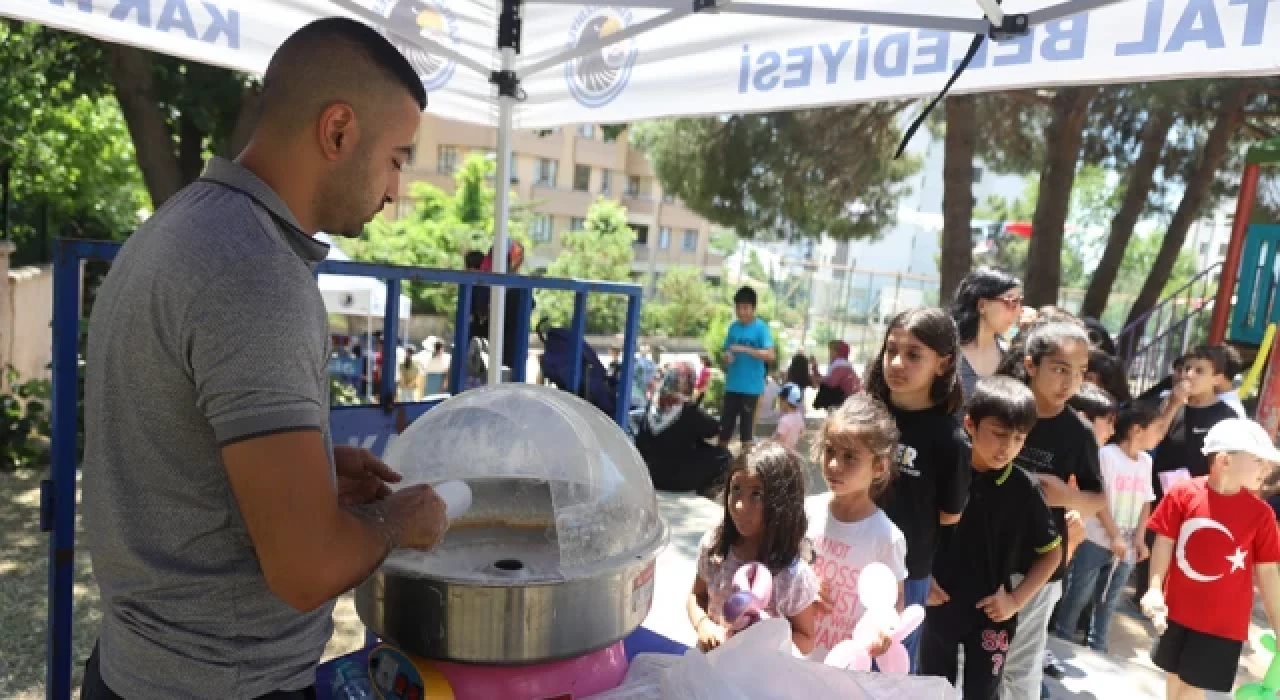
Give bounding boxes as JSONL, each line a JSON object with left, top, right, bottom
{"left": 40, "top": 239, "right": 641, "bottom": 700}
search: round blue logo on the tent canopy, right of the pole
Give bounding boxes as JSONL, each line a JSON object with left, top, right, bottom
{"left": 564, "top": 8, "right": 636, "bottom": 109}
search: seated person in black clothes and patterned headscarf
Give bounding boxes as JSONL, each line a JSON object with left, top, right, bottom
{"left": 636, "top": 363, "right": 731, "bottom": 494}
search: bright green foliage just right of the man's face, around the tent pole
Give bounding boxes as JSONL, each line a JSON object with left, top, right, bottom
{"left": 338, "top": 155, "right": 529, "bottom": 317}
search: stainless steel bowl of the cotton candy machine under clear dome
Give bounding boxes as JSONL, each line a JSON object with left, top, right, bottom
{"left": 356, "top": 480, "right": 667, "bottom": 664}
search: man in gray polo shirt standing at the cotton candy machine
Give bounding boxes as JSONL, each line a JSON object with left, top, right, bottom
{"left": 82, "top": 18, "right": 445, "bottom": 700}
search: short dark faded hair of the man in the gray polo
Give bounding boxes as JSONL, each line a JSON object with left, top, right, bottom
{"left": 262, "top": 17, "right": 426, "bottom": 128}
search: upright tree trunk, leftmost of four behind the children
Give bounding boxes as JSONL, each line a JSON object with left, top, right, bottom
{"left": 938, "top": 95, "right": 977, "bottom": 307}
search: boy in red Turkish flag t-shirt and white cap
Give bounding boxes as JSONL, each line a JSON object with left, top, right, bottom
{"left": 1142, "top": 418, "right": 1280, "bottom": 700}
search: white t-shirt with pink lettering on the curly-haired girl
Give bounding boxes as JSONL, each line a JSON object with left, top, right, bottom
{"left": 805, "top": 493, "right": 906, "bottom": 662}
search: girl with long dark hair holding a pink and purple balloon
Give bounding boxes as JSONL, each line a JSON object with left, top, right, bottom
{"left": 687, "top": 440, "right": 818, "bottom": 654}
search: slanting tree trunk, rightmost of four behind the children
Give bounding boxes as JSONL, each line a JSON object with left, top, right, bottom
{"left": 1125, "top": 81, "right": 1257, "bottom": 325}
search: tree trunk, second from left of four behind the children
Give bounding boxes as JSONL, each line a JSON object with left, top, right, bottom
{"left": 1023, "top": 87, "right": 1098, "bottom": 307}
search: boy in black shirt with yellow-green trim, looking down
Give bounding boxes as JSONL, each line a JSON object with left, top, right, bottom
{"left": 919, "top": 378, "right": 1062, "bottom": 700}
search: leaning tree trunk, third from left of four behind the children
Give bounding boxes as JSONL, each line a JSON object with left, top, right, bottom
{"left": 1080, "top": 106, "right": 1174, "bottom": 319}
